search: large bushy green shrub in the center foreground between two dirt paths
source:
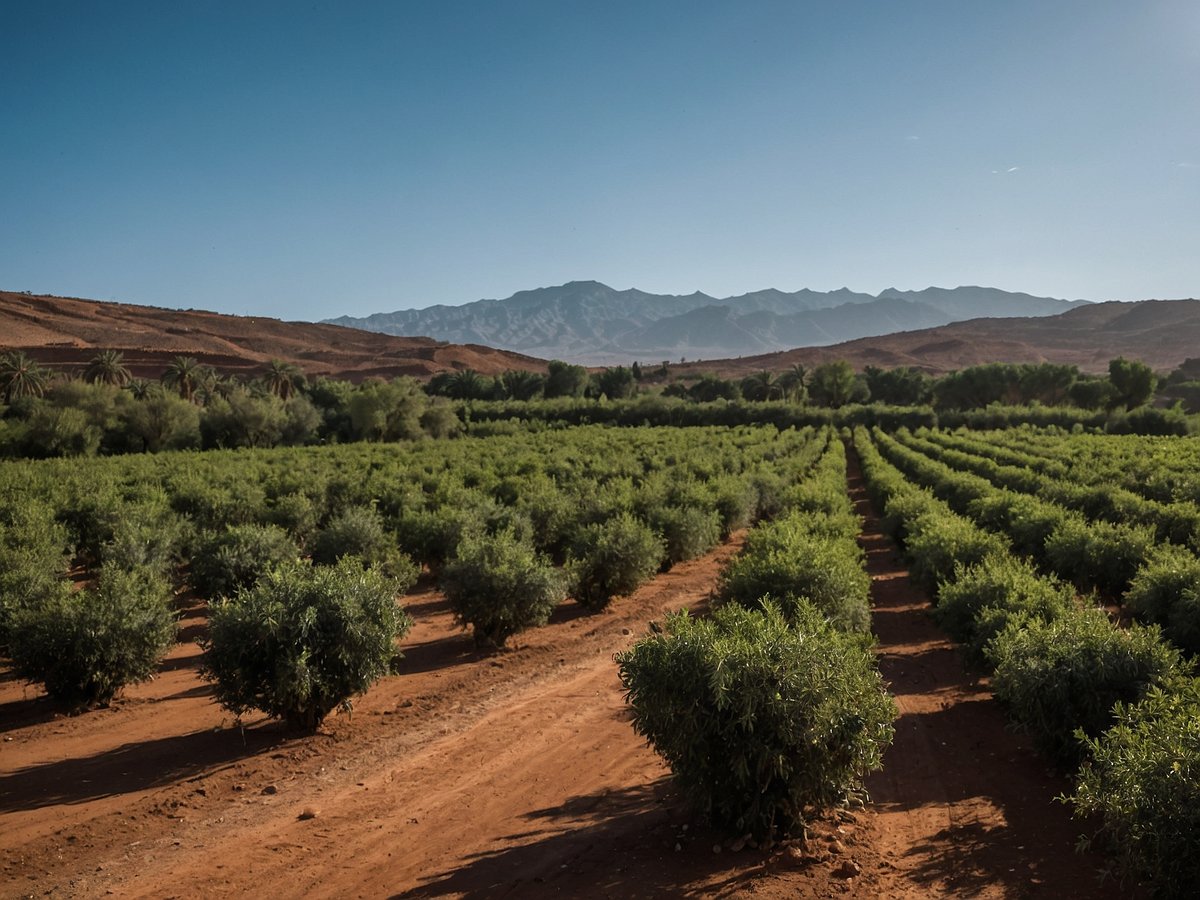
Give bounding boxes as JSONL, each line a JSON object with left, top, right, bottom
{"left": 617, "top": 604, "right": 896, "bottom": 838}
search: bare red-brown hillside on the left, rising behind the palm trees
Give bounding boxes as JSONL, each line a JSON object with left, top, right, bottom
{"left": 0, "top": 290, "right": 546, "bottom": 382}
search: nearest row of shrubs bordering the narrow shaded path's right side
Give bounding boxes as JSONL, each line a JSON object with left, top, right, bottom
{"left": 854, "top": 430, "right": 1200, "bottom": 896}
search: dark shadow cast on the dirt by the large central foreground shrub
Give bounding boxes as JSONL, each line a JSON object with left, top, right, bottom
{"left": 394, "top": 776, "right": 754, "bottom": 900}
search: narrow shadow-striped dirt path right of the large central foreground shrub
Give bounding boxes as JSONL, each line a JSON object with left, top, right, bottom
{"left": 850, "top": 455, "right": 1121, "bottom": 898}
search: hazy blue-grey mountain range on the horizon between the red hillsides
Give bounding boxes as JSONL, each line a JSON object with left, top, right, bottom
{"left": 328, "top": 281, "right": 1086, "bottom": 364}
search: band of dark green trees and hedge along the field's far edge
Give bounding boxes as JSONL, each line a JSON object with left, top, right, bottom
{"left": 0, "top": 350, "right": 1198, "bottom": 458}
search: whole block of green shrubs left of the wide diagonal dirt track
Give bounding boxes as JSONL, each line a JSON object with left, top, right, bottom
{"left": 0, "top": 430, "right": 829, "bottom": 727}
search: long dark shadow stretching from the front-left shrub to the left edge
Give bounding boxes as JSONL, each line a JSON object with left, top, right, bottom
{"left": 0, "top": 724, "right": 294, "bottom": 812}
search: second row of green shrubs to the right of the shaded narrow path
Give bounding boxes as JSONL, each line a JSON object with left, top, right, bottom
{"left": 875, "top": 432, "right": 1200, "bottom": 655}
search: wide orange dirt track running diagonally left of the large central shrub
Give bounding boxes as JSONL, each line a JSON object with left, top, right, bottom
{"left": 0, "top": 536, "right": 882, "bottom": 898}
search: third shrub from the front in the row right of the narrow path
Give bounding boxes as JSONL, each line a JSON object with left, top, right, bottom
{"left": 934, "top": 553, "right": 1074, "bottom": 665}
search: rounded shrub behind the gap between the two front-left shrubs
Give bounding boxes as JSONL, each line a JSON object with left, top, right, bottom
{"left": 191, "top": 524, "right": 300, "bottom": 600}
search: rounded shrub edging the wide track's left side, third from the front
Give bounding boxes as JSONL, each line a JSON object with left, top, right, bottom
{"left": 568, "top": 512, "right": 666, "bottom": 610}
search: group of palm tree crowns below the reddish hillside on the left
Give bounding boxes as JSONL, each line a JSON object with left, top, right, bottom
{"left": 0, "top": 350, "right": 305, "bottom": 403}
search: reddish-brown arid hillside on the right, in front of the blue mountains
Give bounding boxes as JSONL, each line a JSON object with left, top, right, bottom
{"left": 672, "top": 300, "right": 1200, "bottom": 376}
